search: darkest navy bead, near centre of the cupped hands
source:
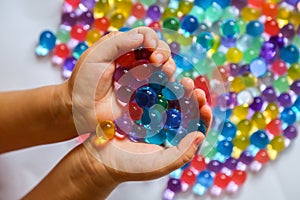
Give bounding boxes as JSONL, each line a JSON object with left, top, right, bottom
{"left": 135, "top": 86, "right": 157, "bottom": 108}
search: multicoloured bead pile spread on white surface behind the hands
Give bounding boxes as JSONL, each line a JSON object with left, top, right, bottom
{"left": 37, "top": 0, "right": 300, "bottom": 199}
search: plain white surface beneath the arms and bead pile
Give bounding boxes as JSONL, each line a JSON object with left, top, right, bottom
{"left": 0, "top": 0, "right": 300, "bottom": 200}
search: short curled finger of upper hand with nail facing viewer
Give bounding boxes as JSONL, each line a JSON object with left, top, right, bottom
{"left": 150, "top": 40, "right": 171, "bottom": 66}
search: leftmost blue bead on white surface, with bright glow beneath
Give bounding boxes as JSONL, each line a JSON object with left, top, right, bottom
{"left": 35, "top": 31, "right": 56, "bottom": 56}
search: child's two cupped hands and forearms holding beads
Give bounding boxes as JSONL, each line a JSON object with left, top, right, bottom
{"left": 0, "top": 27, "right": 211, "bottom": 199}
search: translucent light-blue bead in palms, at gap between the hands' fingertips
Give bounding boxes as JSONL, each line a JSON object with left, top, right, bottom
{"left": 162, "top": 82, "right": 184, "bottom": 100}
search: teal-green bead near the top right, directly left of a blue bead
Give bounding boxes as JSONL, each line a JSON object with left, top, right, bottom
{"left": 221, "top": 19, "right": 240, "bottom": 39}
